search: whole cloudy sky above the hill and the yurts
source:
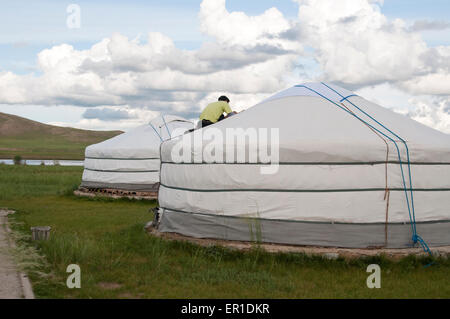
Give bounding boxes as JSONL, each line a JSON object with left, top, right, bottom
{"left": 0, "top": 0, "right": 450, "bottom": 133}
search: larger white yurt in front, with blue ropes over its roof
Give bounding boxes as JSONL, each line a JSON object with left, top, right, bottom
{"left": 158, "top": 83, "right": 450, "bottom": 248}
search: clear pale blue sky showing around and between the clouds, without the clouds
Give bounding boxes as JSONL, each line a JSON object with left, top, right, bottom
{"left": 0, "top": 0, "right": 450, "bottom": 132}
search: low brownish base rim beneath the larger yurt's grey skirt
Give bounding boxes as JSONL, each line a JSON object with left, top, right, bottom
{"left": 145, "top": 223, "right": 450, "bottom": 260}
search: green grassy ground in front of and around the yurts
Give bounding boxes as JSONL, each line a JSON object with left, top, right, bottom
{"left": 0, "top": 165, "right": 450, "bottom": 298}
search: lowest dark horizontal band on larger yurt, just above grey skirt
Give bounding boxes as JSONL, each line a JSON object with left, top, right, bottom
{"left": 160, "top": 206, "right": 450, "bottom": 226}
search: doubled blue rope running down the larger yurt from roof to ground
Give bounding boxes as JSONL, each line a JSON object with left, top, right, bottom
{"left": 295, "top": 83, "right": 430, "bottom": 252}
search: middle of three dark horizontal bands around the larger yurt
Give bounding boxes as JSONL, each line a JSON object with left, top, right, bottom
{"left": 160, "top": 183, "right": 450, "bottom": 193}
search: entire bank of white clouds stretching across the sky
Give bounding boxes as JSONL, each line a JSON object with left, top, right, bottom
{"left": 0, "top": 0, "right": 450, "bottom": 135}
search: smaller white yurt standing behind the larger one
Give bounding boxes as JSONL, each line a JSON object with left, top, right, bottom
{"left": 81, "top": 115, "right": 194, "bottom": 192}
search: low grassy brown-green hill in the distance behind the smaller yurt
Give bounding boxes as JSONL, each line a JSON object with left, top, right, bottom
{"left": 0, "top": 112, "right": 123, "bottom": 160}
